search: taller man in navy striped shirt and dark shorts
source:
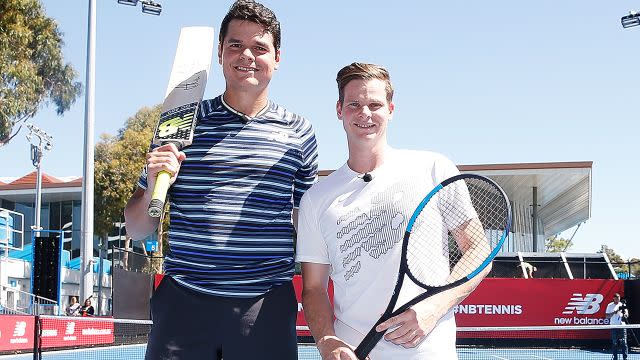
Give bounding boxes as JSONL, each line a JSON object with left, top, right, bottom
{"left": 125, "top": 0, "right": 317, "bottom": 360}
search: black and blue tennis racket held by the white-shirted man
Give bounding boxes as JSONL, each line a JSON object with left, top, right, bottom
{"left": 355, "top": 174, "right": 511, "bottom": 360}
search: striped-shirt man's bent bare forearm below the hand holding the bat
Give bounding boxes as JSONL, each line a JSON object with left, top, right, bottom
{"left": 124, "top": 188, "right": 159, "bottom": 240}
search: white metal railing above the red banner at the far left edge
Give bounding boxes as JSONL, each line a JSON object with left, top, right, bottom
{"left": 0, "top": 285, "right": 60, "bottom": 315}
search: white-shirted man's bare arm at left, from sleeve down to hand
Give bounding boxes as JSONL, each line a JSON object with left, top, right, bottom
{"left": 302, "top": 263, "right": 357, "bottom": 360}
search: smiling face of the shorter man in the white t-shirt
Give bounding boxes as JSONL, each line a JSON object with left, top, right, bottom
{"left": 336, "top": 79, "right": 393, "bottom": 144}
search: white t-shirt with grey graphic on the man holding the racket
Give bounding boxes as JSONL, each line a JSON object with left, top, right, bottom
{"left": 296, "top": 149, "right": 459, "bottom": 360}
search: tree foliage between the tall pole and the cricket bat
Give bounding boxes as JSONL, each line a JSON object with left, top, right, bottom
{"left": 94, "top": 105, "right": 160, "bottom": 242}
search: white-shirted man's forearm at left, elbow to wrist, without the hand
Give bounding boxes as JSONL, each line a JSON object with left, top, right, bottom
{"left": 302, "top": 289, "right": 336, "bottom": 345}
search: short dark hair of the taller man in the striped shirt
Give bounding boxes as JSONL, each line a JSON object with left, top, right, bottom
{"left": 219, "top": 0, "right": 280, "bottom": 51}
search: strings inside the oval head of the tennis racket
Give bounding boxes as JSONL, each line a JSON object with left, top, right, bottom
{"left": 406, "top": 178, "right": 508, "bottom": 286}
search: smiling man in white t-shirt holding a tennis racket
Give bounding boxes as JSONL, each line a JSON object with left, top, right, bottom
{"left": 297, "top": 63, "right": 488, "bottom": 360}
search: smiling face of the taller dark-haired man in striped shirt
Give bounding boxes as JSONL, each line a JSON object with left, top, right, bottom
{"left": 218, "top": 19, "right": 280, "bottom": 91}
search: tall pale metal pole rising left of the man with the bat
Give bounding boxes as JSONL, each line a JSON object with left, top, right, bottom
{"left": 80, "top": 0, "right": 96, "bottom": 301}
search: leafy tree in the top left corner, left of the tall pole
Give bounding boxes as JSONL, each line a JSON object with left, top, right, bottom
{"left": 0, "top": 0, "right": 82, "bottom": 147}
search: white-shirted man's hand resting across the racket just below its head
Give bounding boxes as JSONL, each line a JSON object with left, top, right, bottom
{"left": 376, "top": 298, "right": 448, "bottom": 348}
